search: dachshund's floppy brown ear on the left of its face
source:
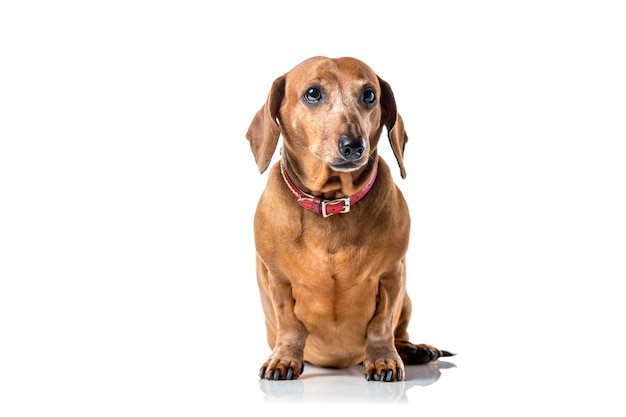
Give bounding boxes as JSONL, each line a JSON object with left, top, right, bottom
{"left": 246, "top": 76, "right": 285, "bottom": 173}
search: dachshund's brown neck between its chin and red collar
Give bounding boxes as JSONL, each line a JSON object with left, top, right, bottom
{"left": 281, "top": 154, "right": 378, "bottom": 199}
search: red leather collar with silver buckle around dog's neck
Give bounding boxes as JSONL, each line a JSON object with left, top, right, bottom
{"left": 280, "top": 161, "right": 378, "bottom": 217}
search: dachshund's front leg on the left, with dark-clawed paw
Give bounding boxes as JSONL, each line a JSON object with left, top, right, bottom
{"left": 259, "top": 272, "right": 307, "bottom": 380}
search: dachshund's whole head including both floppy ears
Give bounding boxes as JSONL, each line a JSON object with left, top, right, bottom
{"left": 241, "top": 57, "right": 408, "bottom": 178}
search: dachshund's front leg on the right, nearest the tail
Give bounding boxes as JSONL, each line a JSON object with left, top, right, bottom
{"left": 363, "top": 278, "right": 404, "bottom": 382}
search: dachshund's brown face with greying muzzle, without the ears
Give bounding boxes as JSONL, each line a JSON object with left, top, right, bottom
{"left": 279, "top": 57, "right": 383, "bottom": 172}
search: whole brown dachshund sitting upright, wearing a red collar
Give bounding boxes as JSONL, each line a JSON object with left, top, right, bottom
{"left": 246, "top": 57, "right": 451, "bottom": 381}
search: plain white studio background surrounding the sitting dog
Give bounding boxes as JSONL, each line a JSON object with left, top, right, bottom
{"left": 0, "top": 0, "right": 626, "bottom": 416}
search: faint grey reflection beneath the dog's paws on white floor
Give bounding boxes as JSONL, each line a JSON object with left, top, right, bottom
{"left": 259, "top": 360, "right": 456, "bottom": 403}
